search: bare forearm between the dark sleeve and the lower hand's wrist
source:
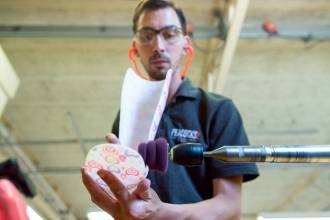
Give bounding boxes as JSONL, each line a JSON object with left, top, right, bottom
{"left": 155, "top": 196, "right": 240, "bottom": 220}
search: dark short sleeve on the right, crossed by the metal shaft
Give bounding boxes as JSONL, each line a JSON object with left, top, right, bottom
{"left": 205, "top": 99, "right": 259, "bottom": 182}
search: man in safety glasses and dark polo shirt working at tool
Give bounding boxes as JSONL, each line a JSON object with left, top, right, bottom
{"left": 82, "top": 0, "right": 258, "bottom": 220}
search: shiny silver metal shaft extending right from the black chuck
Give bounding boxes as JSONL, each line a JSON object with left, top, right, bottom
{"left": 203, "top": 145, "right": 330, "bottom": 163}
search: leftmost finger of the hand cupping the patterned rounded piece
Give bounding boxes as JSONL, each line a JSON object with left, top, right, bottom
{"left": 81, "top": 168, "right": 116, "bottom": 211}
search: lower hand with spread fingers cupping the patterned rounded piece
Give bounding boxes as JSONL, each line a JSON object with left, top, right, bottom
{"left": 81, "top": 168, "right": 162, "bottom": 220}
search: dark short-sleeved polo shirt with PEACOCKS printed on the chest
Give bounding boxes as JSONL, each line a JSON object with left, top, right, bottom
{"left": 112, "top": 78, "right": 258, "bottom": 204}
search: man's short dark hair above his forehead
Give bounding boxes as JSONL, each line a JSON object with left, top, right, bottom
{"left": 133, "top": 0, "right": 187, "bottom": 35}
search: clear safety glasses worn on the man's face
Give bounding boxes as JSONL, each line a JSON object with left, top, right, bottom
{"left": 136, "top": 25, "right": 182, "bottom": 45}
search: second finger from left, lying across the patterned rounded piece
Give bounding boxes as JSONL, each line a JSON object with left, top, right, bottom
{"left": 97, "top": 169, "right": 130, "bottom": 204}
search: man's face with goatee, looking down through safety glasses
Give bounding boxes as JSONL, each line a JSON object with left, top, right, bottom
{"left": 133, "top": 8, "right": 188, "bottom": 80}
